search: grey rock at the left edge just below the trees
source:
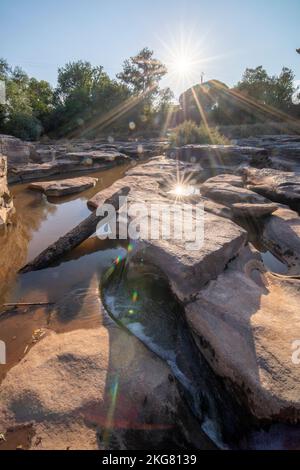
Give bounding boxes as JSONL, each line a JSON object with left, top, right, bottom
{"left": 0, "top": 134, "right": 33, "bottom": 168}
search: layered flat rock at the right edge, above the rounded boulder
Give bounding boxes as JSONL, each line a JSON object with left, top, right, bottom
{"left": 243, "top": 168, "right": 300, "bottom": 209}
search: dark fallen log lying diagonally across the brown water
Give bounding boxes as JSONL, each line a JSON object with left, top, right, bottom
{"left": 19, "top": 186, "right": 130, "bottom": 273}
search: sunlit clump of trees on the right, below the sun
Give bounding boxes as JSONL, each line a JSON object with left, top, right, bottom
{"left": 179, "top": 66, "right": 300, "bottom": 126}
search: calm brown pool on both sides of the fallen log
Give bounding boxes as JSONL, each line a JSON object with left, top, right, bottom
{"left": 0, "top": 165, "right": 128, "bottom": 381}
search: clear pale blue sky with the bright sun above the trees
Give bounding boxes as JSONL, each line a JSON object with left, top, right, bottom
{"left": 0, "top": 0, "right": 300, "bottom": 95}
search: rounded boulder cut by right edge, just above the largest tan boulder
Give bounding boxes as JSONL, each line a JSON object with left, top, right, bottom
{"left": 262, "top": 208, "right": 300, "bottom": 275}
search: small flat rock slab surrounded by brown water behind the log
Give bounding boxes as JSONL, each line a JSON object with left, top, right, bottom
{"left": 28, "top": 177, "right": 97, "bottom": 196}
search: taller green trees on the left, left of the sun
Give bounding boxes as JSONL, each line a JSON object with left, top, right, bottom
{"left": 0, "top": 48, "right": 173, "bottom": 140}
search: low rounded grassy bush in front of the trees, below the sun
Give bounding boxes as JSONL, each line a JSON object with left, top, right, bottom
{"left": 170, "top": 121, "right": 229, "bottom": 146}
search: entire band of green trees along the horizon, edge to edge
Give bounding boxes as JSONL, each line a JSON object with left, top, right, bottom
{"left": 0, "top": 48, "right": 300, "bottom": 140}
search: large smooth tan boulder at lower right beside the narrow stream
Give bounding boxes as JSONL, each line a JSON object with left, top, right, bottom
{"left": 185, "top": 246, "right": 300, "bottom": 426}
